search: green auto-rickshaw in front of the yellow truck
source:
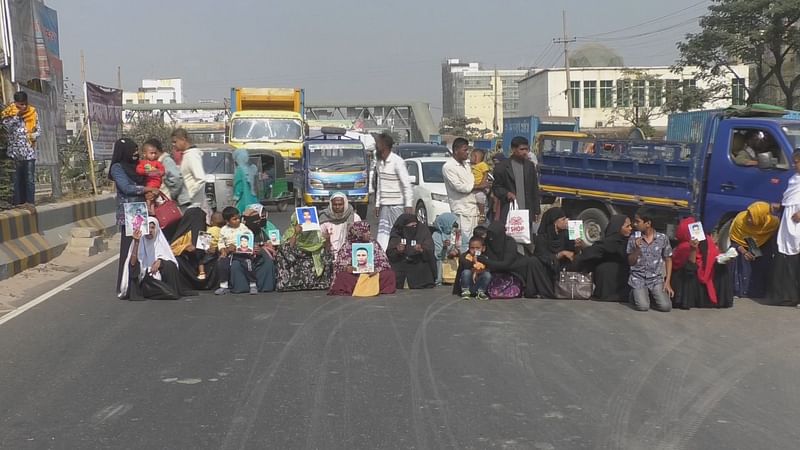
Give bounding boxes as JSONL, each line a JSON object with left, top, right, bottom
{"left": 250, "top": 149, "right": 295, "bottom": 211}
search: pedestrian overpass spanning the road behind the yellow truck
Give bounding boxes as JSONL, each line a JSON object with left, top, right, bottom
{"left": 122, "top": 102, "right": 439, "bottom": 142}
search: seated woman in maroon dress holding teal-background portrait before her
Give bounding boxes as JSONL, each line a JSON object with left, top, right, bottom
{"left": 328, "top": 222, "right": 397, "bottom": 295}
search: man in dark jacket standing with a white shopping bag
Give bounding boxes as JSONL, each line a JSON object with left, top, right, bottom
{"left": 492, "top": 136, "right": 541, "bottom": 227}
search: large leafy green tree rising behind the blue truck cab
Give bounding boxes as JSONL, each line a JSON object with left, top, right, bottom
{"left": 677, "top": 0, "right": 800, "bottom": 109}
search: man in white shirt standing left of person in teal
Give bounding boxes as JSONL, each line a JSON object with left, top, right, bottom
{"left": 172, "top": 128, "right": 211, "bottom": 217}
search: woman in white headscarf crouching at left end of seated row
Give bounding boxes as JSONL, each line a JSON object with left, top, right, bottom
{"left": 119, "top": 217, "right": 195, "bottom": 300}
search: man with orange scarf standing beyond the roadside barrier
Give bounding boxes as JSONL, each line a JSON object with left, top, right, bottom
{"left": 2, "top": 91, "right": 39, "bottom": 207}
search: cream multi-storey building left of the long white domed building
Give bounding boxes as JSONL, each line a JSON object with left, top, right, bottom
{"left": 442, "top": 59, "right": 530, "bottom": 132}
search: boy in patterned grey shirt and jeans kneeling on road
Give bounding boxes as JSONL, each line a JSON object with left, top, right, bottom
{"left": 627, "top": 208, "right": 675, "bottom": 312}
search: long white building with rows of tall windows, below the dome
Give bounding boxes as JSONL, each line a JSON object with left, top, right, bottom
{"left": 518, "top": 65, "right": 748, "bottom": 128}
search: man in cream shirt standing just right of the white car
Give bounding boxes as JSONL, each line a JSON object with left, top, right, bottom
{"left": 442, "top": 138, "right": 488, "bottom": 252}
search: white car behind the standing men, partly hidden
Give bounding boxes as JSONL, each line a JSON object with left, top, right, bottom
{"left": 406, "top": 157, "right": 450, "bottom": 225}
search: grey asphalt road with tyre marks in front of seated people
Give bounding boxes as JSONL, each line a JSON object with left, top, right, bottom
{"left": 0, "top": 212, "right": 800, "bottom": 449}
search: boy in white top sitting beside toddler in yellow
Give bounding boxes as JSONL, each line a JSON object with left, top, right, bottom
{"left": 214, "top": 206, "right": 258, "bottom": 295}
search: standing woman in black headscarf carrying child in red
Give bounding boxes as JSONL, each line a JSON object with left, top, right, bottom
{"left": 108, "top": 138, "right": 158, "bottom": 294}
